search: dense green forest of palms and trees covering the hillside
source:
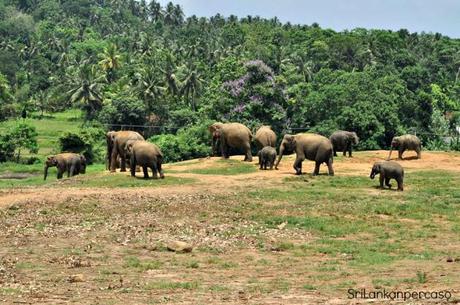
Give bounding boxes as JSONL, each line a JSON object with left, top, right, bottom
{"left": 0, "top": 0, "right": 460, "bottom": 159}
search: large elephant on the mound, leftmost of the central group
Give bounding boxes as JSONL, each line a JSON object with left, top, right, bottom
{"left": 209, "top": 123, "right": 252, "bottom": 162}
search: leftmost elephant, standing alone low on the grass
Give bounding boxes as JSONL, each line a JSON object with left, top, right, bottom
{"left": 43, "top": 153, "right": 86, "bottom": 180}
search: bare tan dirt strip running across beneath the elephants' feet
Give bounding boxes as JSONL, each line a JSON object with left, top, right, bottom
{"left": 0, "top": 150, "right": 460, "bottom": 207}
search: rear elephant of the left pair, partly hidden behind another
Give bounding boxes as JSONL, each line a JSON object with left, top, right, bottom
{"left": 106, "top": 131, "right": 144, "bottom": 172}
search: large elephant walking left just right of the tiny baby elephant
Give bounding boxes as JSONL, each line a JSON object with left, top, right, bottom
{"left": 275, "top": 133, "right": 334, "bottom": 176}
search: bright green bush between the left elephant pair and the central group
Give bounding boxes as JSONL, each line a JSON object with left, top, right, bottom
{"left": 148, "top": 121, "right": 211, "bottom": 162}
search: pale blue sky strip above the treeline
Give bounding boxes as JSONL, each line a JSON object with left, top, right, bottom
{"left": 159, "top": 0, "right": 460, "bottom": 38}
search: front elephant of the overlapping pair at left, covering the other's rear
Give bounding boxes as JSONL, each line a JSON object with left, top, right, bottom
{"left": 126, "top": 141, "right": 165, "bottom": 179}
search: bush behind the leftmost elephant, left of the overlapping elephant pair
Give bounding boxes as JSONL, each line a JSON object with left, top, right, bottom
{"left": 59, "top": 127, "right": 105, "bottom": 164}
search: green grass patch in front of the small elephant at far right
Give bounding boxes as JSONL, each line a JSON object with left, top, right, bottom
{"left": 246, "top": 171, "right": 460, "bottom": 268}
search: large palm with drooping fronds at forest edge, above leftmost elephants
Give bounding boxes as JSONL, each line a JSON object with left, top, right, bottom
{"left": 67, "top": 63, "right": 104, "bottom": 120}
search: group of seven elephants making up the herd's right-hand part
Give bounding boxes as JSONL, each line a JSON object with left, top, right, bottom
{"left": 209, "top": 122, "right": 422, "bottom": 191}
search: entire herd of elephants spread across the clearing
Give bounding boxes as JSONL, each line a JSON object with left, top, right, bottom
{"left": 44, "top": 122, "right": 421, "bottom": 190}
